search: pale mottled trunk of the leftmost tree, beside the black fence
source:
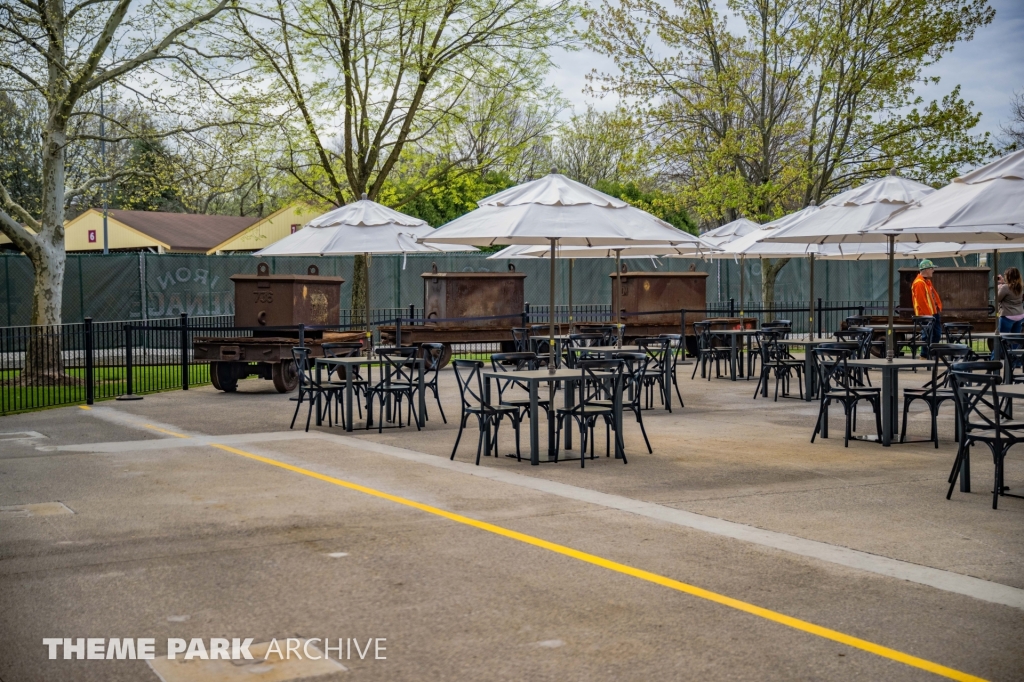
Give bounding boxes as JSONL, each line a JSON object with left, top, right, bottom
{"left": 19, "top": 125, "right": 72, "bottom": 386}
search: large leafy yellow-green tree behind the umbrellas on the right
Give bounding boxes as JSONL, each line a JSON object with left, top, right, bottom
{"left": 587, "top": 0, "right": 993, "bottom": 302}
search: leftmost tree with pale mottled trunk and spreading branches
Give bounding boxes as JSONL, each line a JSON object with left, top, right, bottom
{"left": 0, "top": 0, "right": 230, "bottom": 384}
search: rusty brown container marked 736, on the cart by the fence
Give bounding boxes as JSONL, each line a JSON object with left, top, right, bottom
{"left": 231, "top": 263, "right": 344, "bottom": 327}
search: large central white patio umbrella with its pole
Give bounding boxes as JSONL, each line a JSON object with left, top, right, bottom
{"left": 419, "top": 172, "right": 699, "bottom": 364}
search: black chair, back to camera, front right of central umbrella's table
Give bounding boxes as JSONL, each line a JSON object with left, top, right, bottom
{"left": 555, "top": 359, "right": 628, "bottom": 468}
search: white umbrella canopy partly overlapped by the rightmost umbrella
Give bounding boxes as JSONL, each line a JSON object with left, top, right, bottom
{"left": 765, "top": 175, "right": 937, "bottom": 244}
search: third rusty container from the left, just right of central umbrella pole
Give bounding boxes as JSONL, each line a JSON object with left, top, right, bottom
{"left": 609, "top": 272, "right": 708, "bottom": 325}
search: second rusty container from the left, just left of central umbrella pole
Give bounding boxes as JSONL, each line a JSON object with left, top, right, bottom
{"left": 422, "top": 266, "right": 526, "bottom": 329}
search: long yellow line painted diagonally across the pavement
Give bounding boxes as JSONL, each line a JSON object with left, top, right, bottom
{"left": 210, "top": 443, "right": 985, "bottom": 682}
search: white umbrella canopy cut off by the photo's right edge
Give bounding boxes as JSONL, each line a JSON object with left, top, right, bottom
{"left": 863, "top": 150, "right": 1024, "bottom": 243}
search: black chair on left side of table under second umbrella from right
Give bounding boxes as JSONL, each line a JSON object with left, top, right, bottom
{"left": 811, "top": 343, "right": 882, "bottom": 447}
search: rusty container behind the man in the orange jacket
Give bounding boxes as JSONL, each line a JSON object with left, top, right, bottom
{"left": 899, "top": 267, "right": 993, "bottom": 323}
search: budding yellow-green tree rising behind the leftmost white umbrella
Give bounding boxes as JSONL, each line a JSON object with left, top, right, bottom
{"left": 221, "top": 0, "right": 574, "bottom": 317}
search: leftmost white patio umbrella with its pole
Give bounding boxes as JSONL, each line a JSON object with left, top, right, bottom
{"left": 253, "top": 195, "right": 476, "bottom": 351}
